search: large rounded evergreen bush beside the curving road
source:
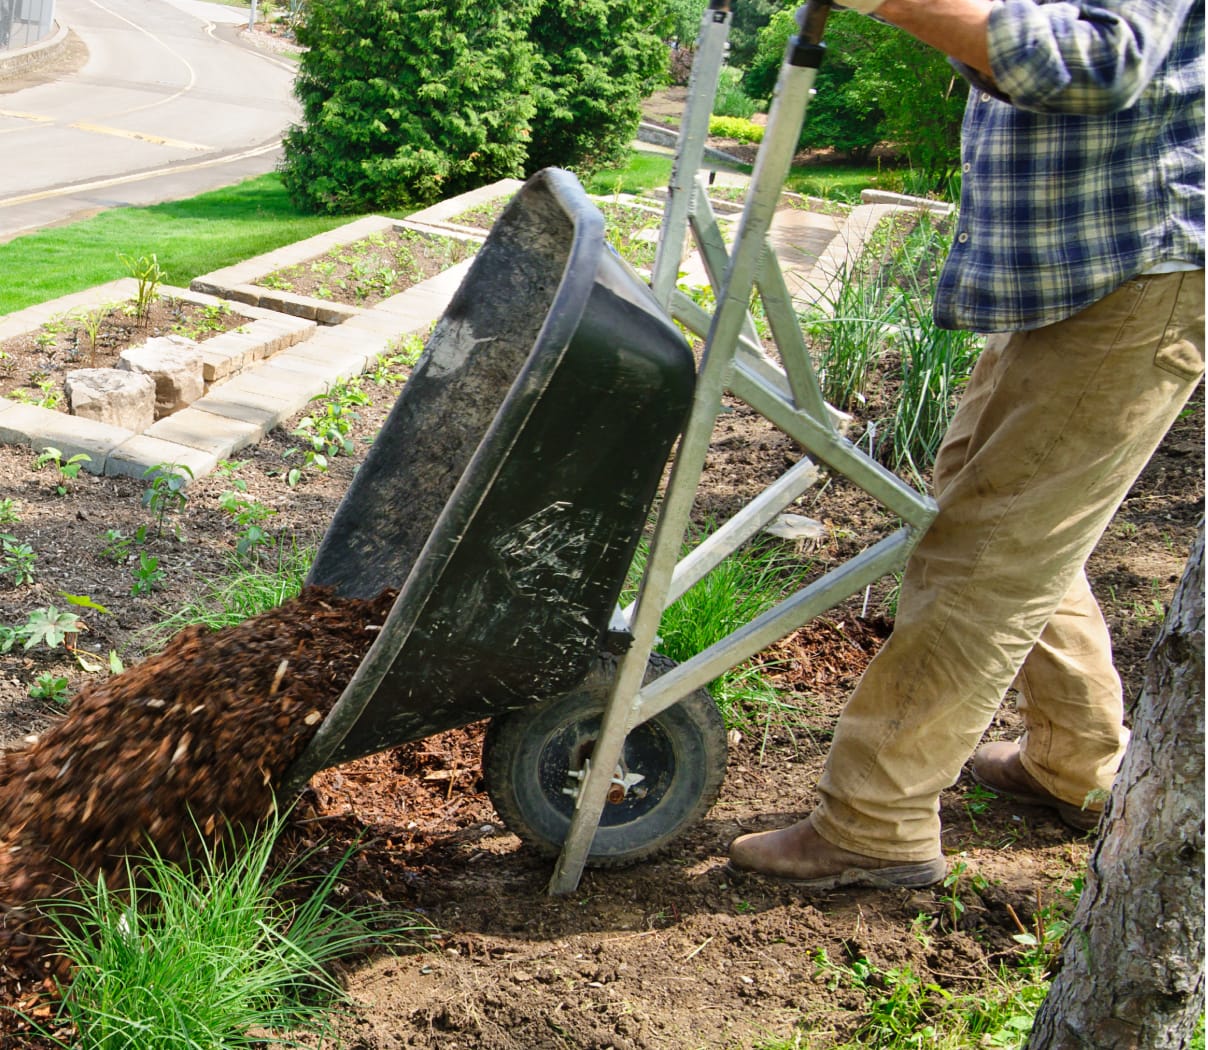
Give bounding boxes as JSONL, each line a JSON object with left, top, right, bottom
{"left": 281, "top": 0, "right": 540, "bottom": 211}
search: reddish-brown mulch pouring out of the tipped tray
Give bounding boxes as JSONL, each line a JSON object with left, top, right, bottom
{"left": 0, "top": 588, "right": 394, "bottom": 975}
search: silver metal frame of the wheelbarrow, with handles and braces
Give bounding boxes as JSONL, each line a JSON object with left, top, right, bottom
{"left": 550, "top": 0, "right": 936, "bottom": 894}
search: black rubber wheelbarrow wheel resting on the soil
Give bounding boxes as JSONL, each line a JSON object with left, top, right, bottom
{"left": 482, "top": 655, "right": 726, "bottom": 868}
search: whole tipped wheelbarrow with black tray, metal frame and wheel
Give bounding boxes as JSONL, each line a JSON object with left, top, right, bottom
{"left": 288, "top": 0, "right": 935, "bottom": 894}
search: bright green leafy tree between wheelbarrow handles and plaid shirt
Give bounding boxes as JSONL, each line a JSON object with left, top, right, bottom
{"left": 743, "top": 10, "right": 968, "bottom": 190}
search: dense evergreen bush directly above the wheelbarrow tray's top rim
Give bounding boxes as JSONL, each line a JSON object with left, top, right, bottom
{"left": 525, "top": 0, "right": 668, "bottom": 173}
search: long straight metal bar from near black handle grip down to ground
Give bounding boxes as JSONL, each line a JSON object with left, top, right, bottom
{"left": 548, "top": 0, "right": 830, "bottom": 895}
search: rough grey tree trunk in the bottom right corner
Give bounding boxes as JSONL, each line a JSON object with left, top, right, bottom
{"left": 1028, "top": 521, "right": 1204, "bottom": 1050}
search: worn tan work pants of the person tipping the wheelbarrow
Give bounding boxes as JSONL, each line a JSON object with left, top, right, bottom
{"left": 813, "top": 271, "right": 1204, "bottom": 860}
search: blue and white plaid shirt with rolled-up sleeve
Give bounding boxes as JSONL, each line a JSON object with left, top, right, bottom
{"left": 935, "top": 0, "right": 1204, "bottom": 332}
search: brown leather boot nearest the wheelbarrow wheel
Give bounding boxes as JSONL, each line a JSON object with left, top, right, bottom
{"left": 728, "top": 817, "right": 947, "bottom": 891}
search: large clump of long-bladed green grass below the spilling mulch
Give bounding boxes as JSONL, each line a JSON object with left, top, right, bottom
{"left": 45, "top": 819, "right": 432, "bottom": 1050}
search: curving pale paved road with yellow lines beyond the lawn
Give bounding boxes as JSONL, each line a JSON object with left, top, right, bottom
{"left": 0, "top": 0, "right": 298, "bottom": 244}
